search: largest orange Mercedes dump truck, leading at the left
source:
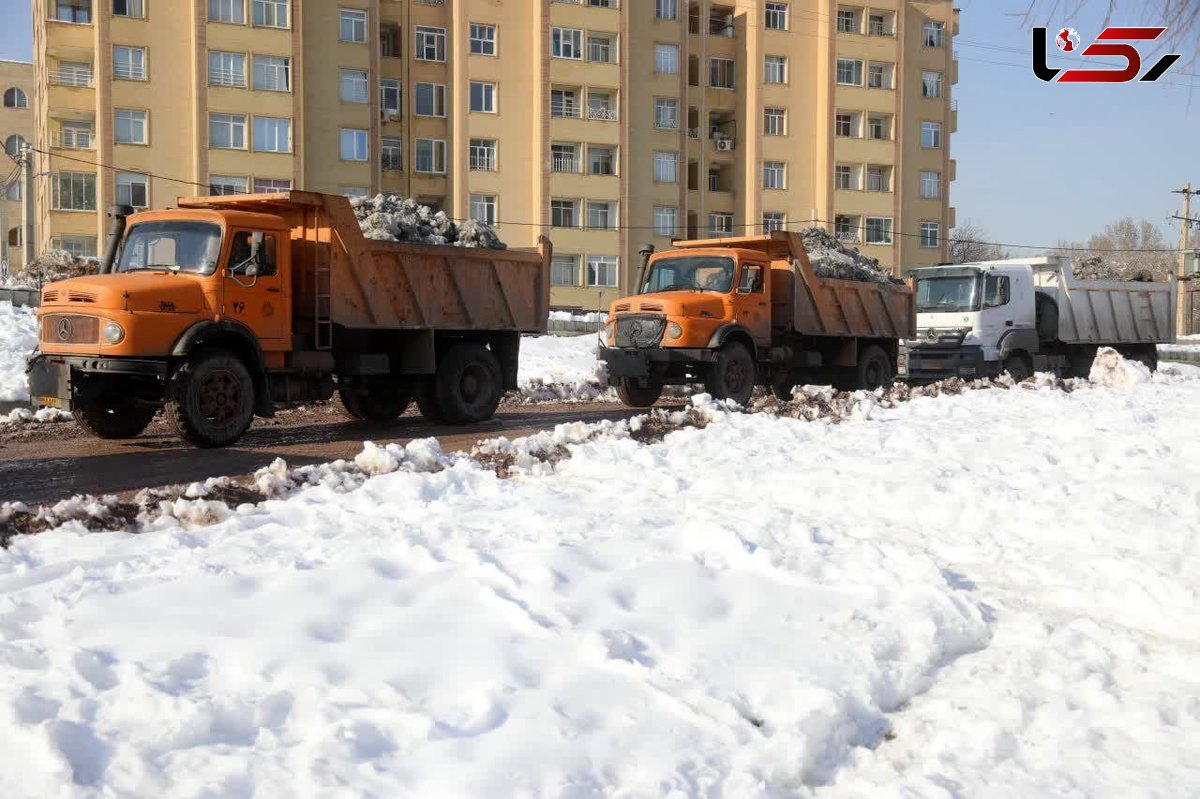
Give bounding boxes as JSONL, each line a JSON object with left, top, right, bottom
{"left": 29, "top": 192, "right": 551, "bottom": 446}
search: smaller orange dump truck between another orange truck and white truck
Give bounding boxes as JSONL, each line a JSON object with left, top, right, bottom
{"left": 600, "top": 232, "right": 916, "bottom": 407}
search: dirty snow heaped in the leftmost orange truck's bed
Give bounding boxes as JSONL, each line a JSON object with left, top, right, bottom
{"left": 350, "top": 194, "right": 505, "bottom": 250}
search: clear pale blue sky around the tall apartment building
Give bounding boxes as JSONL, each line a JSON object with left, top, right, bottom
{"left": 0, "top": 0, "right": 1200, "bottom": 245}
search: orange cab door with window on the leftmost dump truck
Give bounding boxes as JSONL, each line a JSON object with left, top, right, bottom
{"left": 223, "top": 230, "right": 290, "bottom": 350}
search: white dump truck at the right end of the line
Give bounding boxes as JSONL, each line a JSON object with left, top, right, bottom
{"left": 896, "top": 257, "right": 1177, "bottom": 383}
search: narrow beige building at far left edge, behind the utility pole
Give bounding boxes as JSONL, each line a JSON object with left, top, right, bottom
{"left": 0, "top": 60, "right": 34, "bottom": 271}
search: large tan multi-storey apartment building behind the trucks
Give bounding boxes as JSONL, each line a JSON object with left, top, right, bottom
{"left": 34, "top": 0, "right": 958, "bottom": 310}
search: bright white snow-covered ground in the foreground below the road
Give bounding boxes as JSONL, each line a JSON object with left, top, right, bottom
{"left": 0, "top": 364, "right": 1200, "bottom": 799}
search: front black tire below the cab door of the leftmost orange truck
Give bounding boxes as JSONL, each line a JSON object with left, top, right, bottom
{"left": 163, "top": 349, "right": 254, "bottom": 447}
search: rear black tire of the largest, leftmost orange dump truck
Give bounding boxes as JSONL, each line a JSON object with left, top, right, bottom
{"left": 419, "top": 343, "right": 504, "bottom": 425}
